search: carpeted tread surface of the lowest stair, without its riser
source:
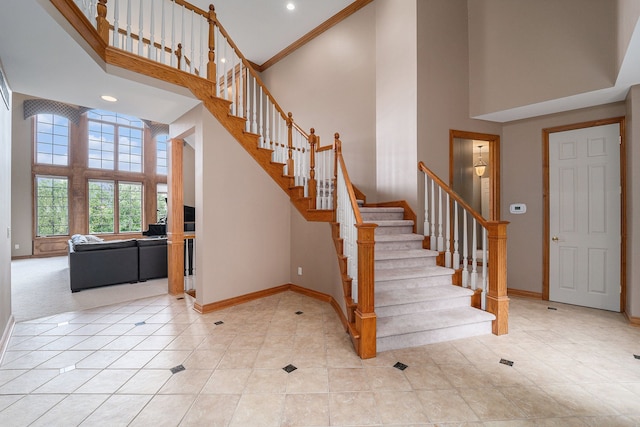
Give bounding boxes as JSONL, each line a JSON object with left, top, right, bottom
{"left": 376, "top": 307, "right": 495, "bottom": 338}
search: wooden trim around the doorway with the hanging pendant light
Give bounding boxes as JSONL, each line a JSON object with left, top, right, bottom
{"left": 449, "top": 129, "right": 500, "bottom": 221}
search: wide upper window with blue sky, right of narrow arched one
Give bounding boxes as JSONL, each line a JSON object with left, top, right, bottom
{"left": 87, "top": 110, "right": 144, "bottom": 172}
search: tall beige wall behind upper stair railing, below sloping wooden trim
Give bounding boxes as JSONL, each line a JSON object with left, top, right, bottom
{"left": 262, "top": 2, "right": 377, "bottom": 201}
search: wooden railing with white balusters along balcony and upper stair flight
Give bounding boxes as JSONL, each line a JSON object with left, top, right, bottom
{"left": 73, "top": 0, "right": 334, "bottom": 210}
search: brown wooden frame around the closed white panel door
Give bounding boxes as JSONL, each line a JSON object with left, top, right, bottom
{"left": 542, "top": 117, "right": 627, "bottom": 313}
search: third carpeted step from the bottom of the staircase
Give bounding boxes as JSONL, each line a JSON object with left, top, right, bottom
{"left": 375, "top": 266, "right": 454, "bottom": 290}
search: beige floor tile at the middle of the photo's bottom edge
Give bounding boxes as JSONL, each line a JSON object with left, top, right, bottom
{"left": 280, "top": 393, "right": 329, "bottom": 427}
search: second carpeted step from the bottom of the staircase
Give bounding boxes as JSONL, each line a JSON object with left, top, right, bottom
{"left": 375, "top": 285, "right": 474, "bottom": 318}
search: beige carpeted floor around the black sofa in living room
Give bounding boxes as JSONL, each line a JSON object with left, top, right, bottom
{"left": 11, "top": 256, "right": 167, "bottom": 322}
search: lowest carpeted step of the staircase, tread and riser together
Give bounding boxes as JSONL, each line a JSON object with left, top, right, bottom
{"left": 376, "top": 307, "right": 495, "bottom": 351}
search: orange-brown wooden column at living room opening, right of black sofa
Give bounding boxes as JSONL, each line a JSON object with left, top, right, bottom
{"left": 167, "top": 139, "right": 184, "bottom": 295}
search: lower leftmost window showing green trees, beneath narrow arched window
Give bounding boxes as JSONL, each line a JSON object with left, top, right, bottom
{"left": 36, "top": 176, "right": 69, "bottom": 237}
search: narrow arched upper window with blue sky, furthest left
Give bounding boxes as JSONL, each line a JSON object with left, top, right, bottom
{"left": 35, "top": 114, "right": 69, "bottom": 166}
